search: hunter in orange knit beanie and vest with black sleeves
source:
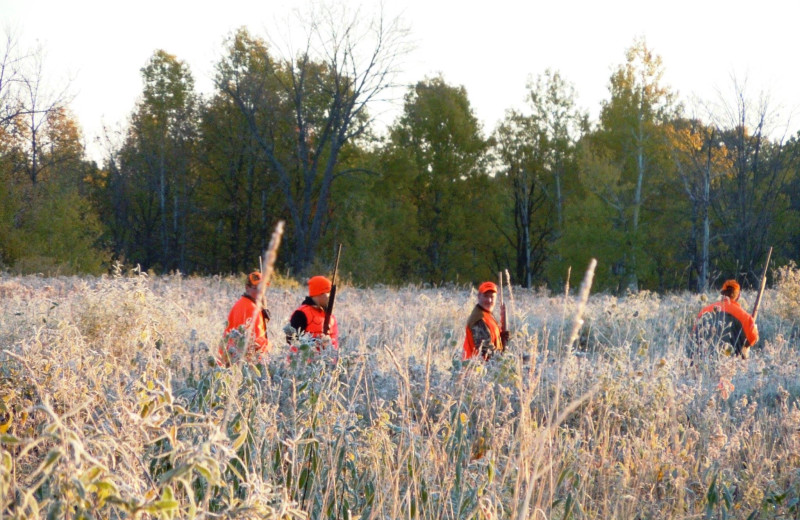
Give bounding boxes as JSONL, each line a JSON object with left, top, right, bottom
{"left": 284, "top": 276, "right": 339, "bottom": 352}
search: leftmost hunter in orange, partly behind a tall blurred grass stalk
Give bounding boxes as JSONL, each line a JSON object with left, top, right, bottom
{"left": 217, "top": 271, "right": 270, "bottom": 366}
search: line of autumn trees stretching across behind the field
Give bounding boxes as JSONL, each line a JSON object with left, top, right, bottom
{"left": 0, "top": 16, "right": 800, "bottom": 292}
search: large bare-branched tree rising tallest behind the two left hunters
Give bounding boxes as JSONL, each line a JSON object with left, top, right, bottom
{"left": 217, "top": 6, "right": 406, "bottom": 272}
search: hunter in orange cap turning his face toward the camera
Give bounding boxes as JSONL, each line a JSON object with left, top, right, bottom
{"left": 463, "top": 282, "right": 508, "bottom": 361}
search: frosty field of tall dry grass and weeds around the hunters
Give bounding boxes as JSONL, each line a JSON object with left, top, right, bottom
{"left": 0, "top": 267, "right": 800, "bottom": 520}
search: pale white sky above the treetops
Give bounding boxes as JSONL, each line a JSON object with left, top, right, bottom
{"left": 0, "top": 0, "right": 800, "bottom": 160}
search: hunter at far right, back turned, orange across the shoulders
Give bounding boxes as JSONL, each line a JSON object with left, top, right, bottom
{"left": 694, "top": 280, "right": 758, "bottom": 359}
